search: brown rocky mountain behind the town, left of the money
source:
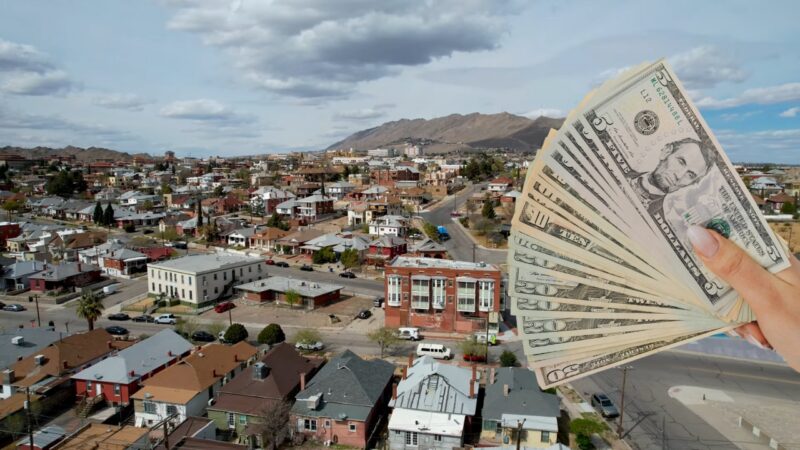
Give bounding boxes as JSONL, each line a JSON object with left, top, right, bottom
{"left": 329, "top": 113, "right": 563, "bottom": 152}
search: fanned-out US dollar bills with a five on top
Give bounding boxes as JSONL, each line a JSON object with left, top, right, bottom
{"left": 508, "top": 61, "right": 789, "bottom": 388}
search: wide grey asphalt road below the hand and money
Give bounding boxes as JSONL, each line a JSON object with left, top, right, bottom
{"left": 572, "top": 352, "right": 800, "bottom": 450}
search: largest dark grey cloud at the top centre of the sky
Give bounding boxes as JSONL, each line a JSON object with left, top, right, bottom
{"left": 168, "top": 0, "right": 517, "bottom": 98}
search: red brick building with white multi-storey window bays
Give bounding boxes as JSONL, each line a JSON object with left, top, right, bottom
{"left": 384, "top": 256, "right": 502, "bottom": 333}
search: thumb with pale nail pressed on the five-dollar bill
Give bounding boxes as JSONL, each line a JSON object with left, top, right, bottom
{"left": 687, "top": 225, "right": 783, "bottom": 314}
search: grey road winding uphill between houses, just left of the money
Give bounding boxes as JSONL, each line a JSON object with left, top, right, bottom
{"left": 420, "top": 183, "right": 507, "bottom": 264}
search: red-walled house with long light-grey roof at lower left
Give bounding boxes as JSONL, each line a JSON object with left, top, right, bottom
{"left": 72, "top": 329, "right": 192, "bottom": 405}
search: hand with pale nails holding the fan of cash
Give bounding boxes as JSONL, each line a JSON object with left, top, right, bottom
{"left": 688, "top": 225, "right": 800, "bottom": 372}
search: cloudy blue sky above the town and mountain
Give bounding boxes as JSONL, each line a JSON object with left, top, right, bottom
{"left": 0, "top": 0, "right": 800, "bottom": 163}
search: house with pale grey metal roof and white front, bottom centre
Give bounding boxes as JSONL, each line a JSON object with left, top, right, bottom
{"left": 389, "top": 356, "right": 480, "bottom": 450}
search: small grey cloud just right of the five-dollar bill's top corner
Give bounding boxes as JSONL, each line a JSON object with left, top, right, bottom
{"left": 667, "top": 45, "right": 748, "bottom": 89}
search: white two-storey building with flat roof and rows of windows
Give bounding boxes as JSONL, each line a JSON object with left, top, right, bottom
{"left": 147, "top": 253, "right": 266, "bottom": 306}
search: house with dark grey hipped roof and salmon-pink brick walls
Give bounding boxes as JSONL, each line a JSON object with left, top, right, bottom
{"left": 292, "top": 350, "right": 394, "bottom": 448}
